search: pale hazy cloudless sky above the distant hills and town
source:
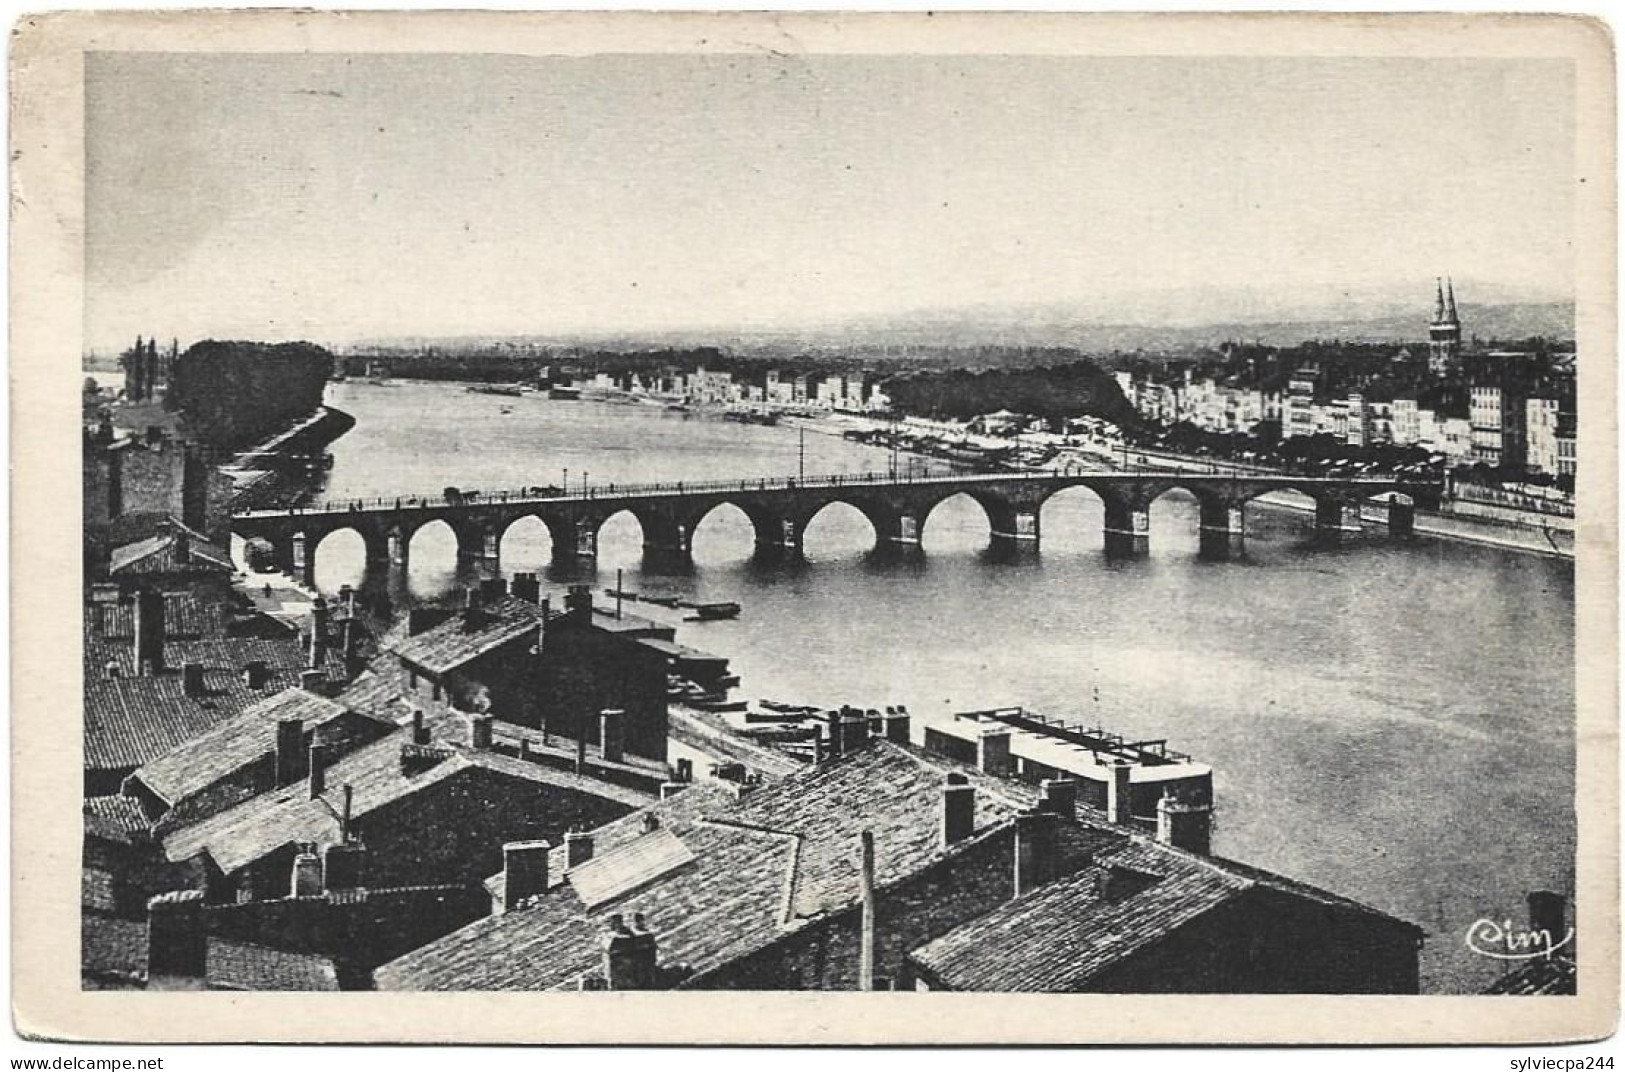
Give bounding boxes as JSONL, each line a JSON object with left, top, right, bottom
{"left": 85, "top": 54, "right": 1575, "bottom": 349}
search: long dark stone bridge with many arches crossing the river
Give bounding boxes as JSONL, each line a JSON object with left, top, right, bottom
{"left": 232, "top": 471, "right": 1443, "bottom": 583}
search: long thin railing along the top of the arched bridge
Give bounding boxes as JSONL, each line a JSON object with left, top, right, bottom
{"left": 236, "top": 466, "right": 1449, "bottom": 518}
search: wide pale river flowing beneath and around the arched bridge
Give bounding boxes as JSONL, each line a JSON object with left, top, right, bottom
{"left": 305, "top": 382, "right": 1575, "bottom": 992}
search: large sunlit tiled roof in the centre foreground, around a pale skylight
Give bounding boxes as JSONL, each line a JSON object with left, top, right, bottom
{"left": 377, "top": 742, "right": 1072, "bottom": 989}
